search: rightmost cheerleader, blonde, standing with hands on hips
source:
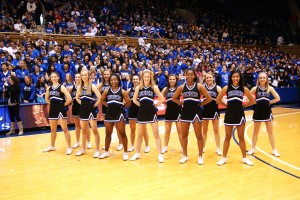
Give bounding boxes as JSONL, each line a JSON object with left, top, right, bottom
{"left": 248, "top": 72, "right": 280, "bottom": 157}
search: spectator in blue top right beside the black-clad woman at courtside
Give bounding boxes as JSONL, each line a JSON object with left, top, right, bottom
{"left": 21, "top": 75, "right": 35, "bottom": 103}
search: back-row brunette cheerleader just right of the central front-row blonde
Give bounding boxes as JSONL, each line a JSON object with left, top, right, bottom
{"left": 162, "top": 74, "right": 183, "bottom": 153}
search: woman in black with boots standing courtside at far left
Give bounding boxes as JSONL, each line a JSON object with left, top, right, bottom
{"left": 5, "top": 75, "right": 23, "bottom": 135}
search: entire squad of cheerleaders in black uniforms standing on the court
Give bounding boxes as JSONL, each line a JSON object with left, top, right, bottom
{"left": 43, "top": 68, "right": 280, "bottom": 166}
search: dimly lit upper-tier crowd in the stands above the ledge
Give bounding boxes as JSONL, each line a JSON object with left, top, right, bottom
{"left": 0, "top": 0, "right": 298, "bottom": 44}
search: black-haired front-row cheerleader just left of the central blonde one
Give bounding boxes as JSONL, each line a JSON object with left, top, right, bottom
{"left": 99, "top": 74, "right": 130, "bottom": 161}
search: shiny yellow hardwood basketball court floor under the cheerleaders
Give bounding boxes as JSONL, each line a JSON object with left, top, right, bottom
{"left": 0, "top": 108, "right": 300, "bottom": 200}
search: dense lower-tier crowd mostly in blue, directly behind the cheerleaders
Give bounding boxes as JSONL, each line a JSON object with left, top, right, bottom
{"left": 0, "top": 30, "right": 300, "bottom": 103}
